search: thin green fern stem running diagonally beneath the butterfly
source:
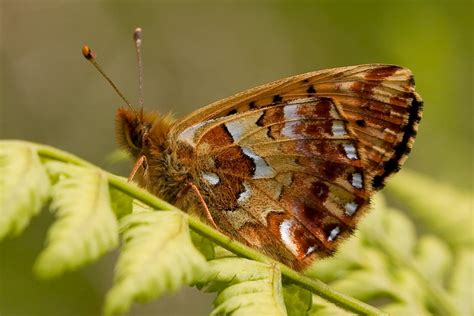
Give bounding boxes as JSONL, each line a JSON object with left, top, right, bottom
{"left": 5, "top": 141, "right": 386, "bottom": 315}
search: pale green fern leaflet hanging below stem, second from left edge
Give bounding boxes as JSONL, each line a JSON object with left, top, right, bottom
{"left": 34, "top": 162, "right": 118, "bottom": 278}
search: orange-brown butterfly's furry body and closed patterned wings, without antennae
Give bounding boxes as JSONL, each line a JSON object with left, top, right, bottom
{"left": 117, "top": 64, "right": 422, "bottom": 269}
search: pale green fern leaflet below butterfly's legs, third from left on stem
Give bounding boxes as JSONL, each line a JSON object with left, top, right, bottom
{"left": 105, "top": 206, "right": 206, "bottom": 315}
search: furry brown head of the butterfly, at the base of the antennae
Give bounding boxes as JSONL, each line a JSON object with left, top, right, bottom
{"left": 115, "top": 108, "right": 173, "bottom": 158}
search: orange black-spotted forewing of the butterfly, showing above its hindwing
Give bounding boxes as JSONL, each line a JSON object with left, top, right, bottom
{"left": 171, "top": 64, "right": 422, "bottom": 189}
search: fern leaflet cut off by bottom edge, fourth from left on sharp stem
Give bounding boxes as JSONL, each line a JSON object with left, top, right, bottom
{"left": 198, "top": 257, "right": 286, "bottom": 316}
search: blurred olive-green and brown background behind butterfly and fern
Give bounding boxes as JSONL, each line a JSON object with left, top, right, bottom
{"left": 0, "top": 0, "right": 474, "bottom": 315}
